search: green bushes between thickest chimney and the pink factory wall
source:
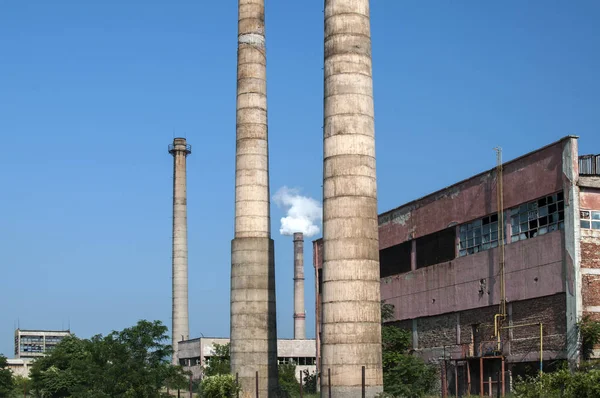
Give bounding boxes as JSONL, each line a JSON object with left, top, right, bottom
{"left": 381, "top": 302, "right": 437, "bottom": 398}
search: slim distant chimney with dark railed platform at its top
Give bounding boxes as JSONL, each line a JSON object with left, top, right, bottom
{"left": 169, "top": 138, "right": 192, "bottom": 365}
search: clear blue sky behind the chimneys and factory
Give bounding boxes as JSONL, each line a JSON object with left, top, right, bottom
{"left": 0, "top": 0, "right": 600, "bottom": 357}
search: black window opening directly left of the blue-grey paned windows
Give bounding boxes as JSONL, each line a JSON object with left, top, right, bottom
{"left": 416, "top": 227, "right": 456, "bottom": 268}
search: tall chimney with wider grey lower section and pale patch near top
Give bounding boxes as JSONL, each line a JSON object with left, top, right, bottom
{"left": 231, "top": 0, "right": 277, "bottom": 397}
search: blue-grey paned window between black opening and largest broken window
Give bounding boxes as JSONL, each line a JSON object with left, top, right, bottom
{"left": 458, "top": 213, "right": 499, "bottom": 257}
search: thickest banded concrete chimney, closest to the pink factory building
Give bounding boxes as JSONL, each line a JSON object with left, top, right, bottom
{"left": 321, "top": 0, "right": 383, "bottom": 398}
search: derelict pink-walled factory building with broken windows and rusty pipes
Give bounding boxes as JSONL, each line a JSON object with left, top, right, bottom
{"left": 313, "top": 136, "right": 600, "bottom": 395}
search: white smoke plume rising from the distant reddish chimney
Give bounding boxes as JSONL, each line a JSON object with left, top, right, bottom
{"left": 273, "top": 186, "right": 323, "bottom": 238}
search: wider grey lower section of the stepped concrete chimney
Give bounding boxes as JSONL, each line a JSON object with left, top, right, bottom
{"left": 231, "top": 238, "right": 278, "bottom": 397}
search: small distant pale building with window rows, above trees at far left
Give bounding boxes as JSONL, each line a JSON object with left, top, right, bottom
{"left": 15, "top": 329, "right": 71, "bottom": 359}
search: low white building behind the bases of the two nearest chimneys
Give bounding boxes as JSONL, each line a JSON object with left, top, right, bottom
{"left": 178, "top": 337, "right": 317, "bottom": 379}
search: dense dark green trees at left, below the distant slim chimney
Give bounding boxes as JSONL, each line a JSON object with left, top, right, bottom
{"left": 26, "top": 321, "right": 187, "bottom": 398}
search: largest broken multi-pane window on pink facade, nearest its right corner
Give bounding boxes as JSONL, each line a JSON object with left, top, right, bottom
{"left": 510, "top": 192, "right": 565, "bottom": 242}
